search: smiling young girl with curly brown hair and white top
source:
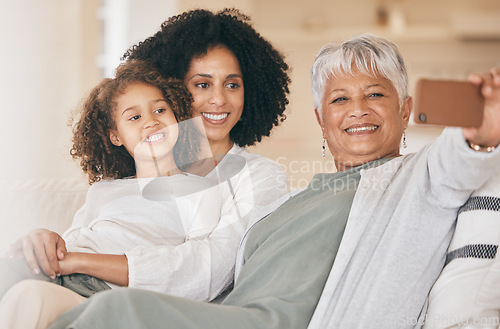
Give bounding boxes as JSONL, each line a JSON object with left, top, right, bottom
{"left": 0, "top": 60, "right": 221, "bottom": 322}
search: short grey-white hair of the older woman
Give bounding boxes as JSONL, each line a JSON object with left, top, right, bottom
{"left": 311, "top": 34, "right": 408, "bottom": 116}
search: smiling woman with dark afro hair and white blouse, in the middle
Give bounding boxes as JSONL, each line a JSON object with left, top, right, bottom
{"left": 1, "top": 9, "right": 290, "bottom": 328}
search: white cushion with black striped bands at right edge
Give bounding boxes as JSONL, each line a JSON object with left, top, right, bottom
{"left": 425, "top": 170, "right": 500, "bottom": 328}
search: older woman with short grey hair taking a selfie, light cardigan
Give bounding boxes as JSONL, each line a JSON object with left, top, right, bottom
{"left": 51, "top": 35, "right": 500, "bottom": 329}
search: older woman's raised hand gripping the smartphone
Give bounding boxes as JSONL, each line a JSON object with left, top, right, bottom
{"left": 463, "top": 67, "right": 500, "bottom": 146}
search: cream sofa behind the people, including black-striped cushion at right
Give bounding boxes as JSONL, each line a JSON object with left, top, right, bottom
{"left": 0, "top": 172, "right": 500, "bottom": 329}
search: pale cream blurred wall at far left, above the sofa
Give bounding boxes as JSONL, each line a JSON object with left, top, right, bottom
{"left": 0, "top": 0, "right": 101, "bottom": 179}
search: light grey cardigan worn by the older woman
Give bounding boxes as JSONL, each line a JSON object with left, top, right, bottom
{"left": 308, "top": 128, "right": 500, "bottom": 329}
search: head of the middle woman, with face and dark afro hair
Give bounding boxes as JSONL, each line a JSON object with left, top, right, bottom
{"left": 124, "top": 9, "right": 290, "bottom": 154}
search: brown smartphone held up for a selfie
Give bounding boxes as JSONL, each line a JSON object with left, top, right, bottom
{"left": 413, "top": 79, "right": 484, "bottom": 127}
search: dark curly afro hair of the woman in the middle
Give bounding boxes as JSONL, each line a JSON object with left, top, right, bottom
{"left": 123, "top": 9, "right": 290, "bottom": 147}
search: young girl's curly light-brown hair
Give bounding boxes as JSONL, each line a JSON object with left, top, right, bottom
{"left": 70, "top": 60, "right": 197, "bottom": 184}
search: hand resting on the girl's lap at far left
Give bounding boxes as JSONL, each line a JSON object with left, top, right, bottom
{"left": 9, "top": 229, "right": 67, "bottom": 279}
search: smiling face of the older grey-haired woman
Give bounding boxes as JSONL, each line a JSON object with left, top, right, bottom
{"left": 317, "top": 68, "right": 411, "bottom": 171}
